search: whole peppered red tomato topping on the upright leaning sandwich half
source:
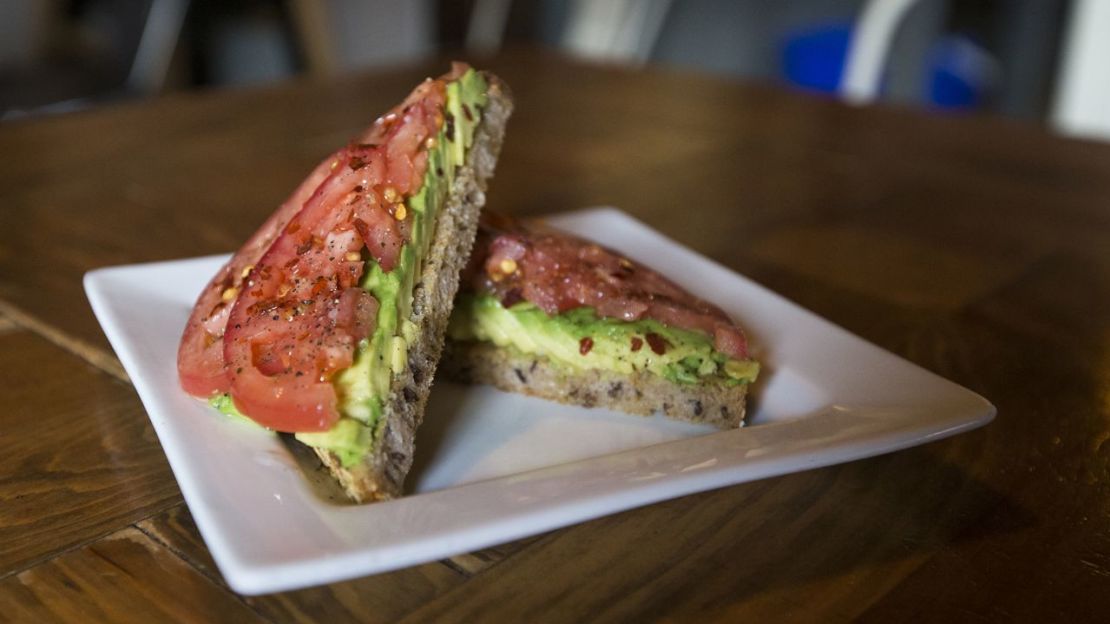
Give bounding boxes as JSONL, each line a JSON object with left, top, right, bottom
{"left": 178, "top": 66, "right": 448, "bottom": 431}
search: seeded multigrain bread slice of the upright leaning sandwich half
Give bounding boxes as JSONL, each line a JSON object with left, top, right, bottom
{"left": 314, "top": 72, "right": 513, "bottom": 503}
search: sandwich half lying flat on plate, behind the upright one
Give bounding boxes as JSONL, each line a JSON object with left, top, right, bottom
{"left": 441, "top": 211, "right": 759, "bottom": 429}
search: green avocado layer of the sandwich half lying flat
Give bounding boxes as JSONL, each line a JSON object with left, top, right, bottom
{"left": 447, "top": 294, "right": 759, "bottom": 384}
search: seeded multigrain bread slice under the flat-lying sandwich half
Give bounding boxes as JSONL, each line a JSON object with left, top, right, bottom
{"left": 441, "top": 341, "right": 748, "bottom": 429}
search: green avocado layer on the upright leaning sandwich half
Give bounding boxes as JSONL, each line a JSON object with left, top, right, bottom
{"left": 210, "top": 69, "right": 487, "bottom": 466}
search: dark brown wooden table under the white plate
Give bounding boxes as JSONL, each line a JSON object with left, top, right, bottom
{"left": 0, "top": 50, "right": 1110, "bottom": 622}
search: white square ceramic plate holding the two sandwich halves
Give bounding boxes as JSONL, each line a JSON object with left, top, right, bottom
{"left": 84, "top": 209, "right": 995, "bottom": 594}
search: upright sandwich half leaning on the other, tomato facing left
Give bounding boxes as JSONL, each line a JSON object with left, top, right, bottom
{"left": 178, "top": 63, "right": 512, "bottom": 502}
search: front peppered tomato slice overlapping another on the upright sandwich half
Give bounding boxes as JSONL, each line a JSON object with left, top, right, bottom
{"left": 223, "top": 148, "right": 382, "bottom": 431}
